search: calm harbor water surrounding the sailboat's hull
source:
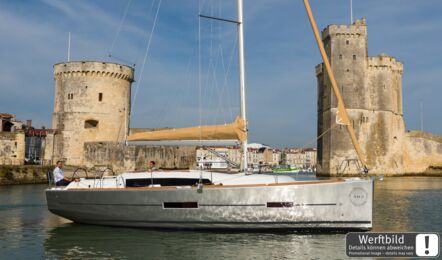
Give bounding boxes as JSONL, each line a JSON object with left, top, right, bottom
{"left": 0, "top": 176, "right": 442, "bottom": 259}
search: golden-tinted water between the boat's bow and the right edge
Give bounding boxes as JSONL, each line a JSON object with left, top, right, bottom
{"left": 373, "top": 177, "right": 442, "bottom": 232}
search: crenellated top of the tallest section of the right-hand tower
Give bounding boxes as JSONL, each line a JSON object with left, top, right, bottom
{"left": 322, "top": 18, "right": 367, "bottom": 40}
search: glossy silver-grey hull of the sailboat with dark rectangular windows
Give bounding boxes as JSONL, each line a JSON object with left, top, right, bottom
{"left": 46, "top": 179, "right": 373, "bottom": 230}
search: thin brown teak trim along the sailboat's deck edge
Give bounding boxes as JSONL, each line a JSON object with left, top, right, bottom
{"left": 67, "top": 179, "right": 345, "bottom": 191}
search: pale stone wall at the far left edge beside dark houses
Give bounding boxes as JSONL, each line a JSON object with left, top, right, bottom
{"left": 0, "top": 131, "right": 25, "bottom": 165}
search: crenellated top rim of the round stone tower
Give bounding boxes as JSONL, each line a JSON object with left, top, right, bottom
{"left": 54, "top": 61, "right": 134, "bottom": 82}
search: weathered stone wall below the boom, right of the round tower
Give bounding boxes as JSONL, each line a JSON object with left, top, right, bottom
{"left": 84, "top": 142, "right": 196, "bottom": 172}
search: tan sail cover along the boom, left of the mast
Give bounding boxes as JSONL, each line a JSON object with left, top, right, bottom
{"left": 127, "top": 117, "right": 247, "bottom": 141}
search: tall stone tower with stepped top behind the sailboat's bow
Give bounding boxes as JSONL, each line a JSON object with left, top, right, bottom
{"left": 316, "top": 19, "right": 405, "bottom": 175}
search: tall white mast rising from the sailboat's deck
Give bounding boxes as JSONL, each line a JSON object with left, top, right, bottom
{"left": 237, "top": 0, "right": 248, "bottom": 173}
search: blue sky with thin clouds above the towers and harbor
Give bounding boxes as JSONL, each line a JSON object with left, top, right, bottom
{"left": 0, "top": 0, "right": 442, "bottom": 147}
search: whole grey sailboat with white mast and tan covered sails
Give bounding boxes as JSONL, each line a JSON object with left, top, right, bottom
{"left": 46, "top": 0, "right": 374, "bottom": 230}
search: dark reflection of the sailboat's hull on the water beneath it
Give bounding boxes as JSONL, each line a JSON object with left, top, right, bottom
{"left": 44, "top": 224, "right": 345, "bottom": 259}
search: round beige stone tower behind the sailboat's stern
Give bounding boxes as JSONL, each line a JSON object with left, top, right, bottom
{"left": 52, "top": 61, "right": 134, "bottom": 165}
